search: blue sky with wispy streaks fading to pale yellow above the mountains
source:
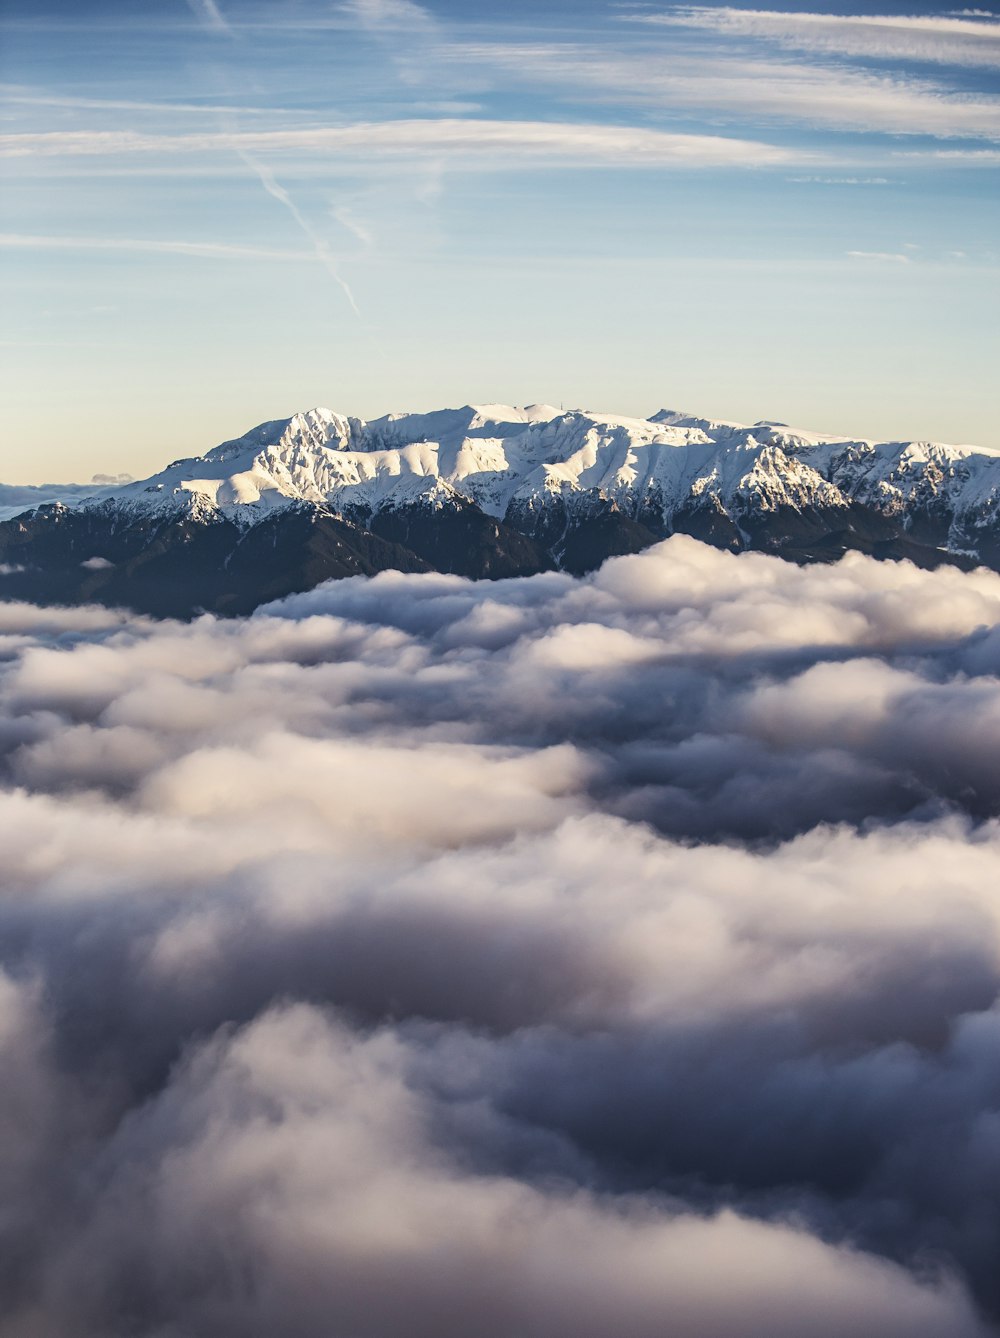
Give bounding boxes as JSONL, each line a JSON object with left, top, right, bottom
{"left": 0, "top": 0, "right": 1000, "bottom": 482}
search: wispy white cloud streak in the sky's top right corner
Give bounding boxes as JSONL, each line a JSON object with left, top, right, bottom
{"left": 634, "top": 5, "right": 1000, "bottom": 67}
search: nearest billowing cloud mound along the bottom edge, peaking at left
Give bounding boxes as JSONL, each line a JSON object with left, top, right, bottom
{"left": 11, "top": 1006, "right": 983, "bottom": 1338}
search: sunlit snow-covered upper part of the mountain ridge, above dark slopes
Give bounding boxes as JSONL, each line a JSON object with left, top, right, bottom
{"left": 7, "top": 404, "right": 1000, "bottom": 547}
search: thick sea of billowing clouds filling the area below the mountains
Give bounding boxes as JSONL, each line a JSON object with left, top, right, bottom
{"left": 0, "top": 537, "right": 1000, "bottom": 1338}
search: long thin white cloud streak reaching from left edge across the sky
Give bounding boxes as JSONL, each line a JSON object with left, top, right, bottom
{"left": 0, "top": 119, "right": 803, "bottom": 167}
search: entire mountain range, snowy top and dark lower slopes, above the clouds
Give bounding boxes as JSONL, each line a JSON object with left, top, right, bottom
{"left": 0, "top": 404, "right": 1000, "bottom": 617}
